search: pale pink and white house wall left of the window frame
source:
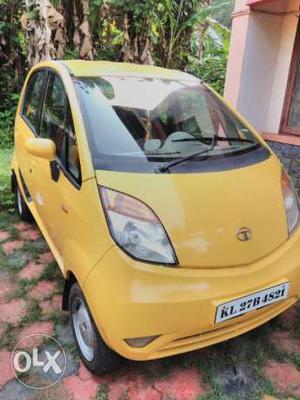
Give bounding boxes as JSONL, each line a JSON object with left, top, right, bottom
{"left": 225, "top": 0, "right": 300, "bottom": 133}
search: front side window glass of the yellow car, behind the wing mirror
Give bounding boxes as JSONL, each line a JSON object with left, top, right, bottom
{"left": 41, "top": 74, "right": 80, "bottom": 180}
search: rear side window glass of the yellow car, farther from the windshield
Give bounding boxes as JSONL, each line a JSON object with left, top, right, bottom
{"left": 22, "top": 71, "right": 47, "bottom": 134}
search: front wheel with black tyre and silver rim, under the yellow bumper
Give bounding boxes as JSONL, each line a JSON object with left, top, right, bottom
{"left": 69, "top": 283, "right": 123, "bottom": 376}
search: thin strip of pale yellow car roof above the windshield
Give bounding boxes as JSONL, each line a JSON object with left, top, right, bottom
{"left": 57, "top": 60, "right": 199, "bottom": 81}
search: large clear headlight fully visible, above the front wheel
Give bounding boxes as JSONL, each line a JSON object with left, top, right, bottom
{"left": 100, "top": 187, "right": 177, "bottom": 266}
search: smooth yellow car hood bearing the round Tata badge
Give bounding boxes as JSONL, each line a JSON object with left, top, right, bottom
{"left": 96, "top": 156, "right": 288, "bottom": 268}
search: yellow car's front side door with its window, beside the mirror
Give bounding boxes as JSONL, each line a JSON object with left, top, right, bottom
{"left": 29, "top": 71, "right": 81, "bottom": 261}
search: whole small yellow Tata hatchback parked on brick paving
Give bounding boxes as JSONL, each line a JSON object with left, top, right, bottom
{"left": 12, "top": 61, "right": 300, "bottom": 374}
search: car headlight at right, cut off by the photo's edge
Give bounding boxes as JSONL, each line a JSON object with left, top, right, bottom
{"left": 281, "top": 170, "right": 300, "bottom": 234}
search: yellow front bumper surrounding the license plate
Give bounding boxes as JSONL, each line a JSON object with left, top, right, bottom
{"left": 83, "top": 229, "right": 300, "bottom": 360}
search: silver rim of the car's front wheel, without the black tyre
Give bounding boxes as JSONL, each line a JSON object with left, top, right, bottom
{"left": 72, "top": 297, "right": 95, "bottom": 361}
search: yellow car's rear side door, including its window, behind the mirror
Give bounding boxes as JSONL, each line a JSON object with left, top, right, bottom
{"left": 15, "top": 69, "right": 48, "bottom": 200}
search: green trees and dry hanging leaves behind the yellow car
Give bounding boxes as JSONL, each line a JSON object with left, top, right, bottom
{"left": 0, "top": 0, "right": 233, "bottom": 149}
